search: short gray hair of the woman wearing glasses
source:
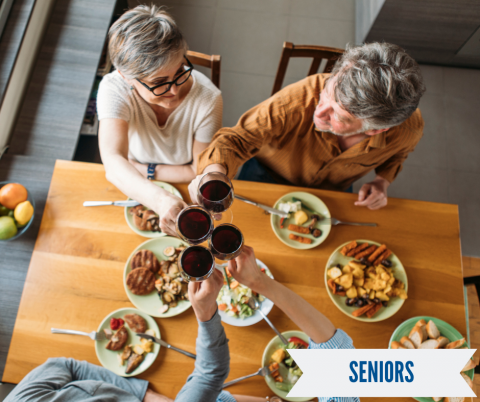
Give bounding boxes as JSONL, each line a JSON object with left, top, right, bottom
{"left": 108, "top": 5, "right": 188, "bottom": 79}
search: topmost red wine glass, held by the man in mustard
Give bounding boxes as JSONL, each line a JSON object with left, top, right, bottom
{"left": 197, "top": 172, "right": 234, "bottom": 226}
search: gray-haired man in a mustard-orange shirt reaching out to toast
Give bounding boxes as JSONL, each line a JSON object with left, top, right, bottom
{"left": 186, "top": 43, "right": 425, "bottom": 214}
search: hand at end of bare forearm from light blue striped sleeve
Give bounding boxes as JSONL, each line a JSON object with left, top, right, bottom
{"left": 228, "top": 245, "right": 268, "bottom": 293}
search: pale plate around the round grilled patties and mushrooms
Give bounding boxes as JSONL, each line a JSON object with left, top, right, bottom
{"left": 123, "top": 236, "right": 192, "bottom": 318}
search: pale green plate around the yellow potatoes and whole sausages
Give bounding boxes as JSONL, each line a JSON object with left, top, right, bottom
{"left": 325, "top": 240, "right": 408, "bottom": 322}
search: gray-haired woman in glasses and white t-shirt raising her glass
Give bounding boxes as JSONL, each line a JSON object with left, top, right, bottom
{"left": 97, "top": 5, "right": 223, "bottom": 234}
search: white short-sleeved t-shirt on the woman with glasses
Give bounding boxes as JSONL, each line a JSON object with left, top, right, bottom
{"left": 97, "top": 70, "right": 223, "bottom": 165}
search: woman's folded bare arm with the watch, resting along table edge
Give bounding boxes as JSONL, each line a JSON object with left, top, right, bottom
{"left": 129, "top": 140, "right": 209, "bottom": 183}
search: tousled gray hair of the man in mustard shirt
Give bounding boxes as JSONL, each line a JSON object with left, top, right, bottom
{"left": 332, "top": 42, "right": 425, "bottom": 130}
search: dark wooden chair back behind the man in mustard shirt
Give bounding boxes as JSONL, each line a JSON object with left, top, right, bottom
{"left": 272, "top": 42, "right": 344, "bottom": 95}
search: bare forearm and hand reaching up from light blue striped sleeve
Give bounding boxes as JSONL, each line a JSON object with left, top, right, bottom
{"left": 228, "top": 246, "right": 336, "bottom": 343}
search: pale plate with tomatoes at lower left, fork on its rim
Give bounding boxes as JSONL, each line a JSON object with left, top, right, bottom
{"left": 95, "top": 308, "right": 160, "bottom": 377}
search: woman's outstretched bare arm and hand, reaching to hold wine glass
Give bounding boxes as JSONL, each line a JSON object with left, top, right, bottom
{"left": 98, "top": 119, "right": 187, "bottom": 236}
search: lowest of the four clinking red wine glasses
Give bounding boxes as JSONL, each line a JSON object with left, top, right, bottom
{"left": 178, "top": 246, "right": 215, "bottom": 282}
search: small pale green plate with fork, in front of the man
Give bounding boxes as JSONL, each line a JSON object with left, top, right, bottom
{"left": 270, "top": 191, "right": 332, "bottom": 250}
